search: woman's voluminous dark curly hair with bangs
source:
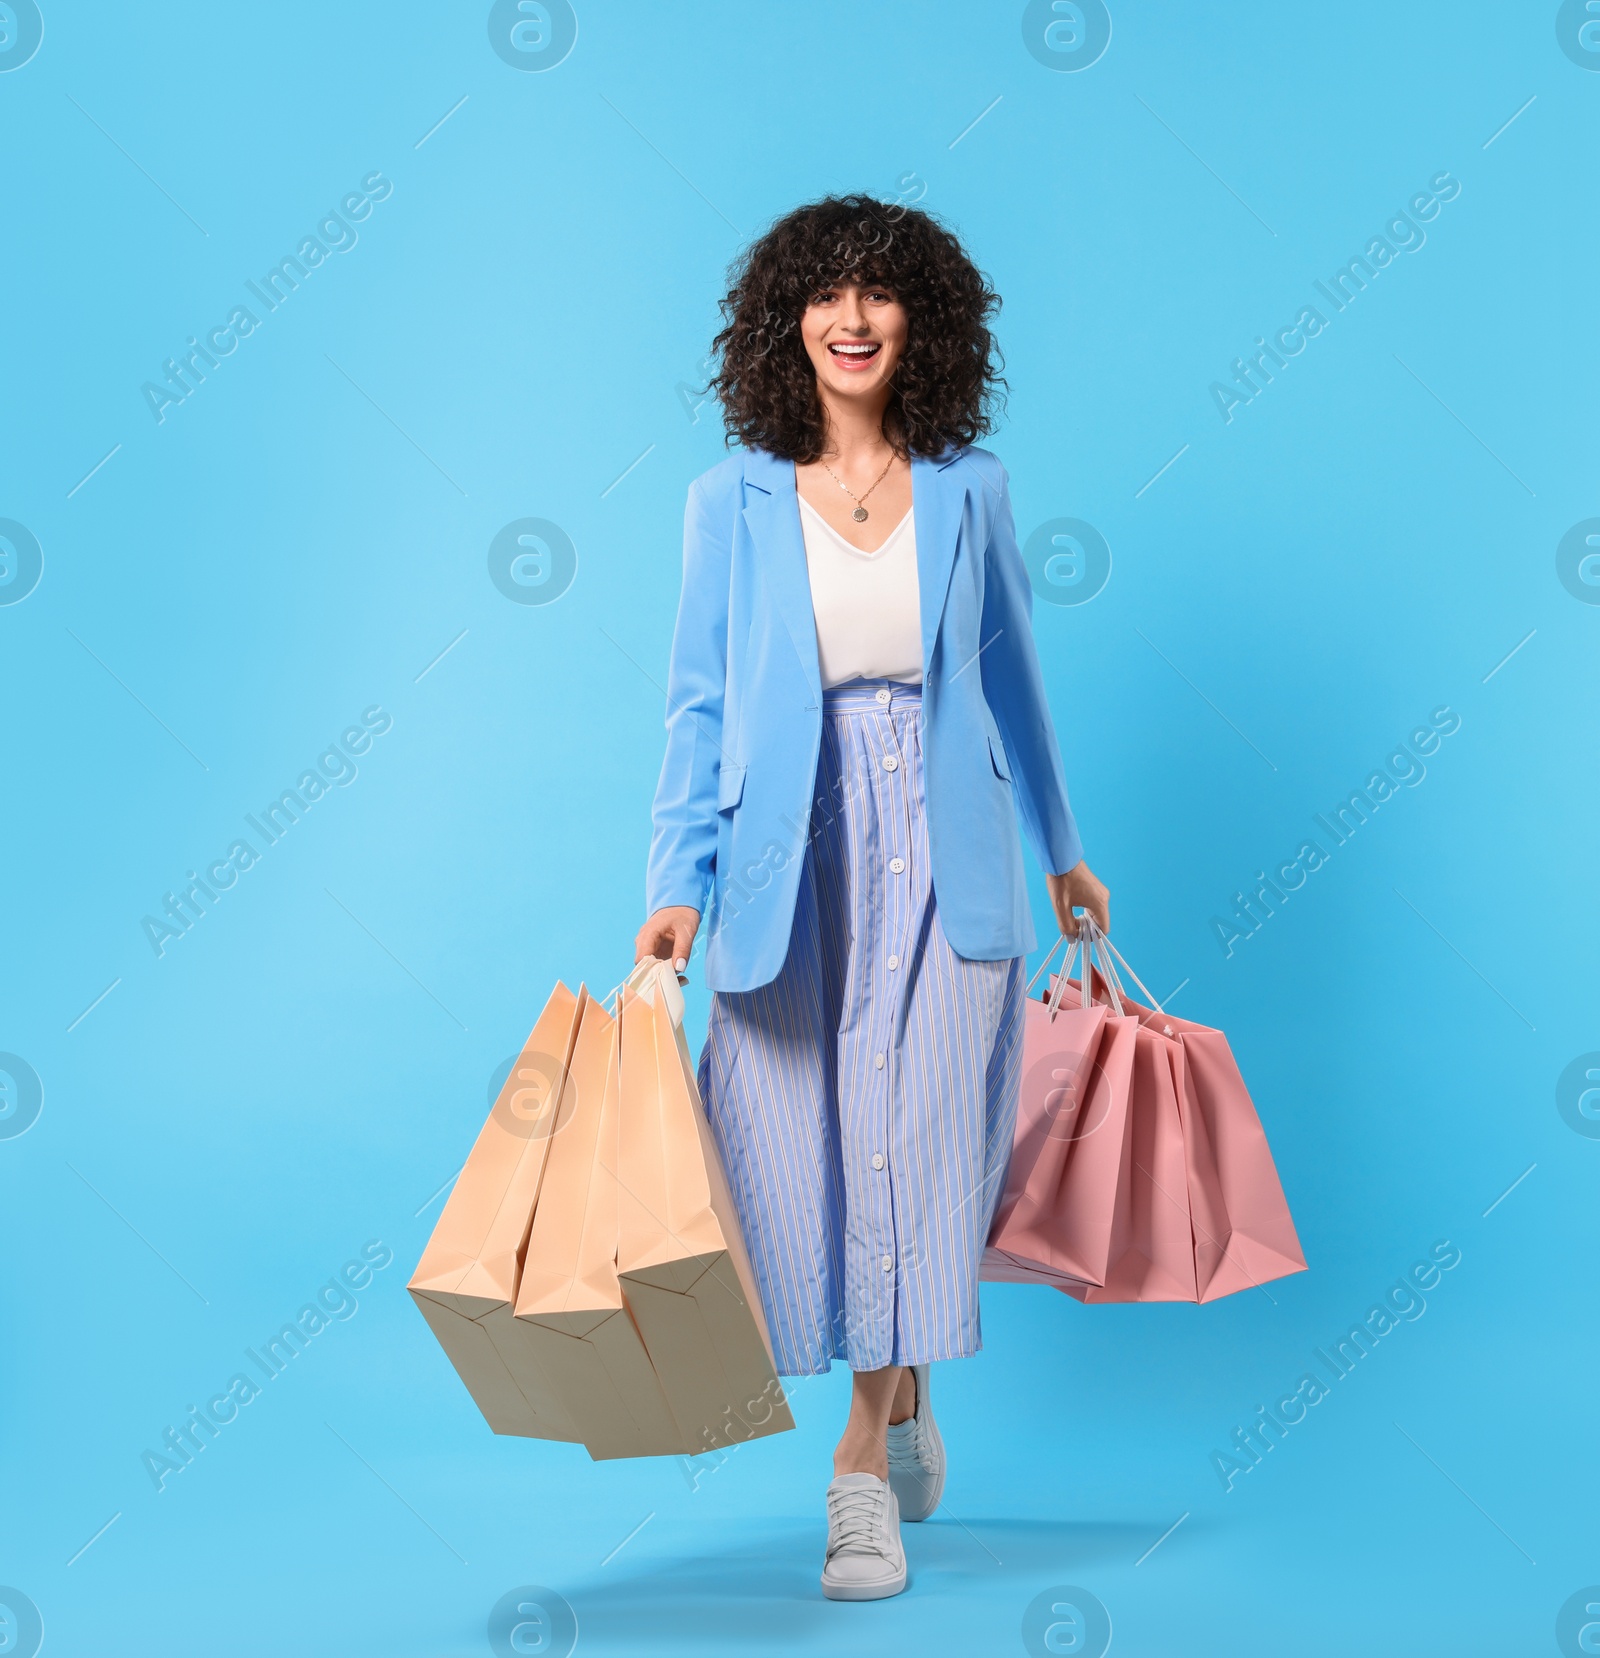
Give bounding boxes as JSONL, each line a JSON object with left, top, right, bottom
{"left": 711, "top": 196, "right": 1005, "bottom": 463}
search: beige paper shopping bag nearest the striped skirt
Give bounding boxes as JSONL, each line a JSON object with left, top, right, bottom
{"left": 617, "top": 962, "right": 794, "bottom": 1452}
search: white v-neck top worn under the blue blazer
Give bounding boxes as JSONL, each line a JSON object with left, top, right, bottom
{"left": 799, "top": 496, "right": 922, "bottom": 690}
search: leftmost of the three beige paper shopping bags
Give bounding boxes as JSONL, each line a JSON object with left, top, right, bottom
{"left": 408, "top": 985, "right": 589, "bottom": 1439}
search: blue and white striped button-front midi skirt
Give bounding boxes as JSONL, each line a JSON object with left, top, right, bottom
{"left": 700, "top": 680, "right": 1023, "bottom": 1376}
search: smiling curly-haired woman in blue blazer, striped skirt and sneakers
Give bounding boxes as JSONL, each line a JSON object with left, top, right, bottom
{"left": 635, "top": 196, "right": 1109, "bottom": 1600}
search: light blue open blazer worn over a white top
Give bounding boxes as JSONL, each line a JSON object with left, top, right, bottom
{"left": 647, "top": 448, "right": 1083, "bottom": 990}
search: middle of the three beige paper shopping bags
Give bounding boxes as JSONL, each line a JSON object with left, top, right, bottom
{"left": 496, "top": 998, "right": 686, "bottom": 1459}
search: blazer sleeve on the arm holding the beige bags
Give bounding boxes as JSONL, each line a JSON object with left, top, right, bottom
{"left": 645, "top": 479, "right": 733, "bottom": 915}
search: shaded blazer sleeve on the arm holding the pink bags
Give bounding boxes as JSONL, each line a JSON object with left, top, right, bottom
{"left": 978, "top": 468, "right": 1083, "bottom": 875}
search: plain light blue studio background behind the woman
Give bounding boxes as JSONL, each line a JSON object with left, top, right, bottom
{"left": 0, "top": 0, "right": 1600, "bottom": 1658}
